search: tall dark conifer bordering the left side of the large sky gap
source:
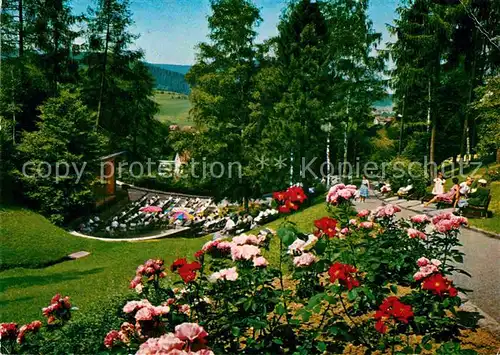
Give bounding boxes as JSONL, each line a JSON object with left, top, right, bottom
{"left": 81, "top": 0, "right": 159, "bottom": 158}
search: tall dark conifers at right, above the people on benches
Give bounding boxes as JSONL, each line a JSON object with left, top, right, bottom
{"left": 388, "top": 0, "right": 500, "bottom": 162}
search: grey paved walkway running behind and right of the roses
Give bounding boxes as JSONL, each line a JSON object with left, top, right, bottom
{"left": 356, "top": 196, "right": 500, "bottom": 321}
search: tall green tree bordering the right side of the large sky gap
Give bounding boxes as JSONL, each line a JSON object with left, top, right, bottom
{"left": 183, "top": 0, "right": 260, "bottom": 199}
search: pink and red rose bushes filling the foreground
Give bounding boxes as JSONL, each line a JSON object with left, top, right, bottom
{"left": 2, "top": 185, "right": 498, "bottom": 354}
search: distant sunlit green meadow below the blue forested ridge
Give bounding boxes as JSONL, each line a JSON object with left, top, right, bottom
{"left": 154, "top": 91, "right": 194, "bottom": 126}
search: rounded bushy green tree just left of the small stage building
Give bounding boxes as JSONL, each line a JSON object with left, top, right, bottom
{"left": 16, "top": 90, "right": 104, "bottom": 223}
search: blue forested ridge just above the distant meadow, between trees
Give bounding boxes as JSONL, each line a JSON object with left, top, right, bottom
{"left": 144, "top": 63, "right": 191, "bottom": 95}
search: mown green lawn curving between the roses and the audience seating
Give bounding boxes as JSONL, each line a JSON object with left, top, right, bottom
{"left": 0, "top": 203, "right": 326, "bottom": 322}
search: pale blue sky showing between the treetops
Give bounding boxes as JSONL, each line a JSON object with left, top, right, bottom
{"left": 71, "top": 0, "right": 398, "bottom": 64}
